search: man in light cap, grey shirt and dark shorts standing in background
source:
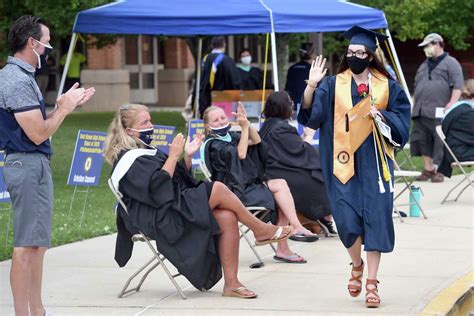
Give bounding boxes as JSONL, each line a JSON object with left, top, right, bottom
{"left": 410, "top": 33, "right": 464, "bottom": 182}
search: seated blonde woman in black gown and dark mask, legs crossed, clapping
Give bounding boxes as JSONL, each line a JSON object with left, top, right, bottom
{"left": 105, "top": 104, "right": 291, "bottom": 298}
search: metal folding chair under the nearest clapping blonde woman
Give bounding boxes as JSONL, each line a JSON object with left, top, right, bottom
{"left": 108, "top": 179, "right": 186, "bottom": 300}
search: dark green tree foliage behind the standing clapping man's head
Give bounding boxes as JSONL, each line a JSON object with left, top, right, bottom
{"left": 0, "top": 0, "right": 114, "bottom": 61}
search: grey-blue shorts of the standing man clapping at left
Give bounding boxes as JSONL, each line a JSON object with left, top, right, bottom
{"left": 3, "top": 153, "right": 54, "bottom": 247}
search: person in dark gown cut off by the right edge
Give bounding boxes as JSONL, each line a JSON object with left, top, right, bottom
{"left": 438, "top": 79, "right": 474, "bottom": 177}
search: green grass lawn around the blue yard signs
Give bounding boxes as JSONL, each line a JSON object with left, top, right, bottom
{"left": 0, "top": 112, "right": 185, "bottom": 261}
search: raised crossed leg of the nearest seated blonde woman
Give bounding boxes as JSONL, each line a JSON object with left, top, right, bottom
{"left": 209, "top": 182, "right": 291, "bottom": 240}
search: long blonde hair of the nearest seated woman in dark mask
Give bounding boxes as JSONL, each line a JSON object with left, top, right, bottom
{"left": 104, "top": 104, "right": 149, "bottom": 165}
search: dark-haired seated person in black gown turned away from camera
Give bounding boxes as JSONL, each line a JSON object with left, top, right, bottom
{"left": 260, "top": 91, "right": 337, "bottom": 236}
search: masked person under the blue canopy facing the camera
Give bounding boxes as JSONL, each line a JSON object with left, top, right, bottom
{"left": 239, "top": 48, "right": 272, "bottom": 90}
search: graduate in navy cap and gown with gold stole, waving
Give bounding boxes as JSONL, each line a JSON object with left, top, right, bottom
{"left": 298, "top": 26, "right": 410, "bottom": 307}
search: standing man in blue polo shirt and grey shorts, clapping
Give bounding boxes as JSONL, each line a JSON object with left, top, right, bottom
{"left": 0, "top": 15, "right": 95, "bottom": 316}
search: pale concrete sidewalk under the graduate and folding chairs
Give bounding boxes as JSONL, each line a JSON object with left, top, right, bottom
{"left": 0, "top": 176, "right": 474, "bottom": 316}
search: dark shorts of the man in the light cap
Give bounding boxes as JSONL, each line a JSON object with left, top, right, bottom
{"left": 410, "top": 116, "right": 443, "bottom": 165}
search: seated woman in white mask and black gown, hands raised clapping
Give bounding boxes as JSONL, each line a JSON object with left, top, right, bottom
{"left": 201, "top": 104, "right": 318, "bottom": 263}
